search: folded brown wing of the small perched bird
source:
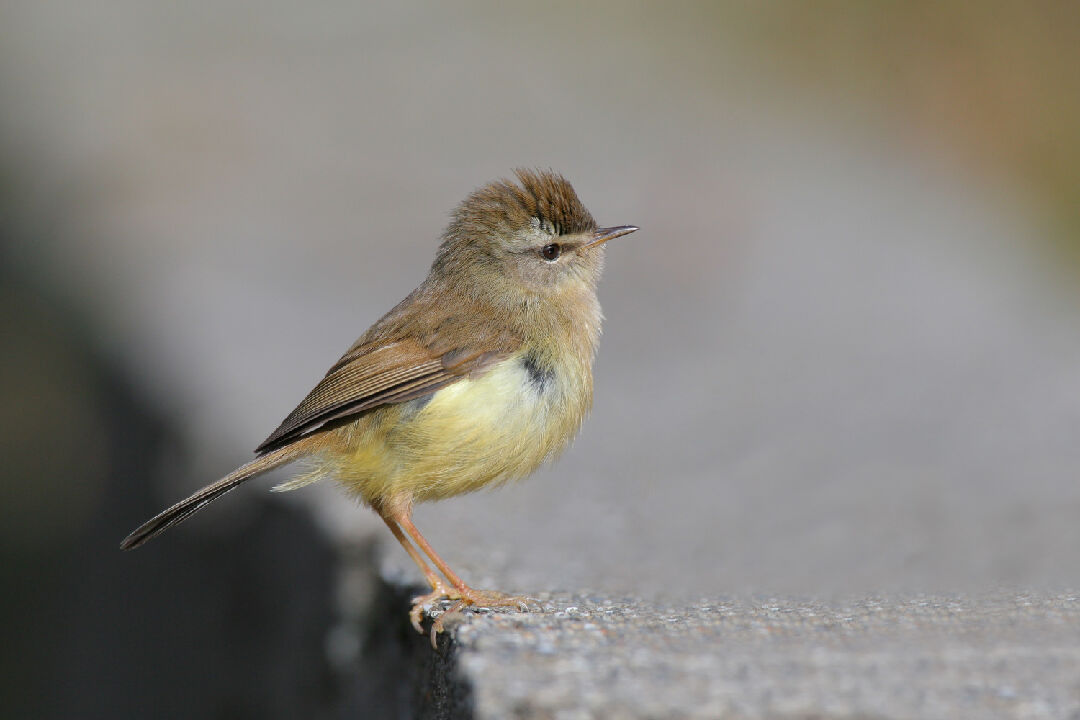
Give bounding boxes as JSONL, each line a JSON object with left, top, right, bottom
{"left": 255, "top": 339, "right": 508, "bottom": 453}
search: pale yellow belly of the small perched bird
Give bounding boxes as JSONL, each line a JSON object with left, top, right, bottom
{"left": 314, "top": 354, "right": 592, "bottom": 504}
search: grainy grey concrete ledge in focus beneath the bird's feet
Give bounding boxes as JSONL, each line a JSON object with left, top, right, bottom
{"left": 408, "top": 593, "right": 1080, "bottom": 720}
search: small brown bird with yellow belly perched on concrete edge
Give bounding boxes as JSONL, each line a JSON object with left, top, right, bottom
{"left": 121, "top": 171, "right": 637, "bottom": 637}
